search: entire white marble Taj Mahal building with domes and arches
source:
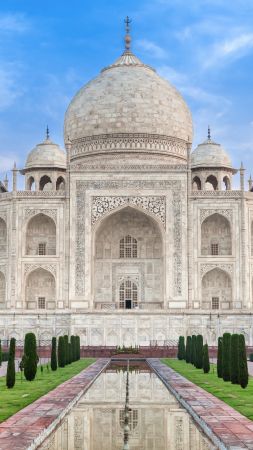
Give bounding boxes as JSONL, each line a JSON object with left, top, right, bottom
{"left": 0, "top": 22, "right": 253, "bottom": 345}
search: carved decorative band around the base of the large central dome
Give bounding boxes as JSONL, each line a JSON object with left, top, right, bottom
{"left": 70, "top": 133, "right": 187, "bottom": 160}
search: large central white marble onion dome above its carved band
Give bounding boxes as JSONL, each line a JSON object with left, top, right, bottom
{"left": 64, "top": 52, "right": 192, "bottom": 146}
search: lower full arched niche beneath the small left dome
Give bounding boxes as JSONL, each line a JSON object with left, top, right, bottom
{"left": 26, "top": 268, "right": 55, "bottom": 310}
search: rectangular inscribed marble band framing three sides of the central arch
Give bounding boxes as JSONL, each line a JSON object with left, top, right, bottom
{"left": 75, "top": 180, "right": 182, "bottom": 296}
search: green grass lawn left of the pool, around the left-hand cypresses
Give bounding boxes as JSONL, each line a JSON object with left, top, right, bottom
{"left": 0, "top": 358, "right": 95, "bottom": 422}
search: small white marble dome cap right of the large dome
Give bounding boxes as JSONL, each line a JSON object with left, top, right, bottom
{"left": 191, "top": 138, "right": 232, "bottom": 169}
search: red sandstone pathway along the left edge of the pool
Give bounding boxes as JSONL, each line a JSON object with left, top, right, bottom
{"left": 0, "top": 358, "right": 109, "bottom": 450}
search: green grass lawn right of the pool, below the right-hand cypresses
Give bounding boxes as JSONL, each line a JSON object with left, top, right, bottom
{"left": 161, "top": 358, "right": 253, "bottom": 420}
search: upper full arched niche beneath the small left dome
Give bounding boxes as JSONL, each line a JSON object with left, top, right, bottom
{"left": 26, "top": 213, "right": 56, "bottom": 256}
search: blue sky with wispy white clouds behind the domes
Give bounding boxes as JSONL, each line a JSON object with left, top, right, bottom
{"left": 0, "top": 0, "right": 253, "bottom": 185}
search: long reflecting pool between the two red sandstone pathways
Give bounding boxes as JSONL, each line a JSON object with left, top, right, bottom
{"left": 40, "top": 362, "right": 216, "bottom": 450}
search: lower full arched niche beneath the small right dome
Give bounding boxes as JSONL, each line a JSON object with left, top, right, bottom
{"left": 202, "top": 268, "right": 232, "bottom": 310}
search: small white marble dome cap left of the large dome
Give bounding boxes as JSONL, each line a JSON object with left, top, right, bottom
{"left": 25, "top": 138, "right": 66, "bottom": 169}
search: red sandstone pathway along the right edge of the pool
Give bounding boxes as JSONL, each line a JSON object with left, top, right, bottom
{"left": 148, "top": 358, "right": 253, "bottom": 450}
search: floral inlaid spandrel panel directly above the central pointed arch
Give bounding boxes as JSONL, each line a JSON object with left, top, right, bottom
{"left": 91, "top": 196, "right": 166, "bottom": 227}
